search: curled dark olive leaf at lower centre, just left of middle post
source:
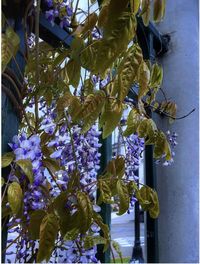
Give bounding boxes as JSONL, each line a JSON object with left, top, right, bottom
{"left": 77, "top": 191, "right": 92, "bottom": 234}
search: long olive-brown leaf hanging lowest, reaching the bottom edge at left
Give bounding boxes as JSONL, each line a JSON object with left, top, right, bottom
{"left": 37, "top": 214, "right": 58, "bottom": 263}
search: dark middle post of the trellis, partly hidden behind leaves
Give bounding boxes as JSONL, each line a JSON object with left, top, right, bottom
{"left": 97, "top": 135, "right": 112, "bottom": 263}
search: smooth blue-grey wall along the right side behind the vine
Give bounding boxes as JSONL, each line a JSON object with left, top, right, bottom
{"left": 156, "top": 0, "right": 199, "bottom": 263}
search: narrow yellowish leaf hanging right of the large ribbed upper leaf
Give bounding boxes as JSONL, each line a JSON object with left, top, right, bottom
{"left": 138, "top": 61, "right": 150, "bottom": 99}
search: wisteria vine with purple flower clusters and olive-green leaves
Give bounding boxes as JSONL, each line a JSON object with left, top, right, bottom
{"left": 2, "top": 0, "right": 180, "bottom": 263}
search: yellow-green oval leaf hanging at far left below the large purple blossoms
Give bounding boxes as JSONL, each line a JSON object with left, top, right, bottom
{"left": 8, "top": 182, "right": 23, "bottom": 214}
